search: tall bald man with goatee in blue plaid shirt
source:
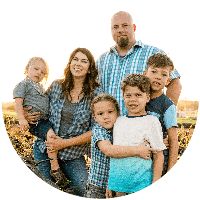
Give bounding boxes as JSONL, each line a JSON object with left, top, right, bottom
{"left": 97, "top": 11, "right": 181, "bottom": 115}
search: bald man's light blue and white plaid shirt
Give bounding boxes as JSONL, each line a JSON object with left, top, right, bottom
{"left": 97, "top": 41, "right": 180, "bottom": 115}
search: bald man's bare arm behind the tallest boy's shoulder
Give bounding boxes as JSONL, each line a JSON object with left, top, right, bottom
{"left": 166, "top": 78, "right": 182, "bottom": 105}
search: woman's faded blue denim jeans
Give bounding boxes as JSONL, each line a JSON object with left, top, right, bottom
{"left": 33, "top": 141, "right": 88, "bottom": 196}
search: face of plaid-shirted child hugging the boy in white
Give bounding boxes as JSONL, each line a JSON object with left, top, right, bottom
{"left": 93, "top": 100, "right": 118, "bottom": 129}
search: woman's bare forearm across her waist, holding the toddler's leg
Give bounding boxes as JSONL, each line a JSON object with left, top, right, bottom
{"left": 46, "top": 131, "right": 92, "bottom": 150}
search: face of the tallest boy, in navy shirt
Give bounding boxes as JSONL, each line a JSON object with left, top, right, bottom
{"left": 145, "top": 66, "right": 171, "bottom": 93}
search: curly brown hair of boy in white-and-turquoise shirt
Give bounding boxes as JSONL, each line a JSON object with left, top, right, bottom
{"left": 121, "top": 74, "right": 151, "bottom": 94}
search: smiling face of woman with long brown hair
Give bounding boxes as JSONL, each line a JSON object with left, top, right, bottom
{"left": 70, "top": 51, "right": 90, "bottom": 79}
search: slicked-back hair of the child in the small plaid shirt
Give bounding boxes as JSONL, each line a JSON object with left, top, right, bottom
{"left": 91, "top": 93, "right": 120, "bottom": 115}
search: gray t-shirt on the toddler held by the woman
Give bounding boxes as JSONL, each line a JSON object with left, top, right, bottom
{"left": 13, "top": 78, "right": 49, "bottom": 117}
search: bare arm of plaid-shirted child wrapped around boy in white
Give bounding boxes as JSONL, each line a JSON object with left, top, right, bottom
{"left": 97, "top": 140, "right": 152, "bottom": 159}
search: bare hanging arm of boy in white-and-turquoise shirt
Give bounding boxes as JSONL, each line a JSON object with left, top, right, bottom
{"left": 152, "top": 151, "right": 164, "bottom": 183}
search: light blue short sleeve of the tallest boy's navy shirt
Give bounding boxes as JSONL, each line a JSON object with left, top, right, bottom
{"left": 164, "top": 104, "right": 177, "bottom": 129}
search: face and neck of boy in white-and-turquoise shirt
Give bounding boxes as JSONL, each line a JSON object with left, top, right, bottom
{"left": 123, "top": 85, "right": 149, "bottom": 116}
